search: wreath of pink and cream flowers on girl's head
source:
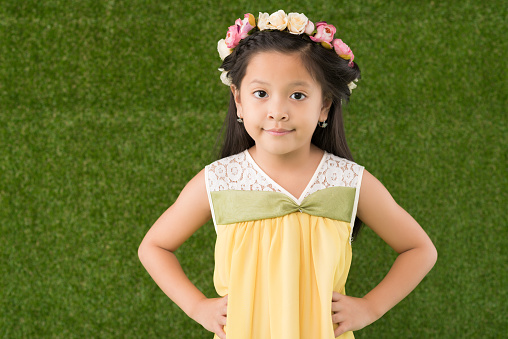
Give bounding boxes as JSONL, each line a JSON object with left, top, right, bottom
{"left": 217, "top": 9, "right": 358, "bottom": 91}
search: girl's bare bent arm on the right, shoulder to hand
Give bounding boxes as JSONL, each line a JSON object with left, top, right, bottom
{"left": 332, "top": 171, "right": 437, "bottom": 336}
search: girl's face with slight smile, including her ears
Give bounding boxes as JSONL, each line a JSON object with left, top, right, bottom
{"left": 231, "top": 52, "right": 331, "bottom": 156}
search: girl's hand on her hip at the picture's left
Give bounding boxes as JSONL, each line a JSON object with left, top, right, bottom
{"left": 192, "top": 296, "right": 228, "bottom": 339}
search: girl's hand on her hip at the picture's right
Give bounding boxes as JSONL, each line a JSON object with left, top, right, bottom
{"left": 332, "top": 291, "right": 377, "bottom": 337}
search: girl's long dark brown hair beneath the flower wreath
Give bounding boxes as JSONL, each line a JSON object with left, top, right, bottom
{"left": 216, "top": 30, "right": 362, "bottom": 242}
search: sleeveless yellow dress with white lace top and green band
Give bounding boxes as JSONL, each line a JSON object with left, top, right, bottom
{"left": 205, "top": 150, "right": 363, "bottom": 339}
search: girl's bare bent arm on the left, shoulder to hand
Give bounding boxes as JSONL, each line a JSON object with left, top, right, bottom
{"left": 138, "top": 170, "right": 227, "bottom": 339}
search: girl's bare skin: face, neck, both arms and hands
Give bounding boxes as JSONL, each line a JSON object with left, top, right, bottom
{"left": 139, "top": 52, "right": 437, "bottom": 339}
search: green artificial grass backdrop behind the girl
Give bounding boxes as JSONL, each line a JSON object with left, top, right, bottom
{"left": 0, "top": 0, "right": 508, "bottom": 338}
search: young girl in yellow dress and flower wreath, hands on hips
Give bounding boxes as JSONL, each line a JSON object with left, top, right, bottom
{"left": 139, "top": 11, "right": 437, "bottom": 339}
